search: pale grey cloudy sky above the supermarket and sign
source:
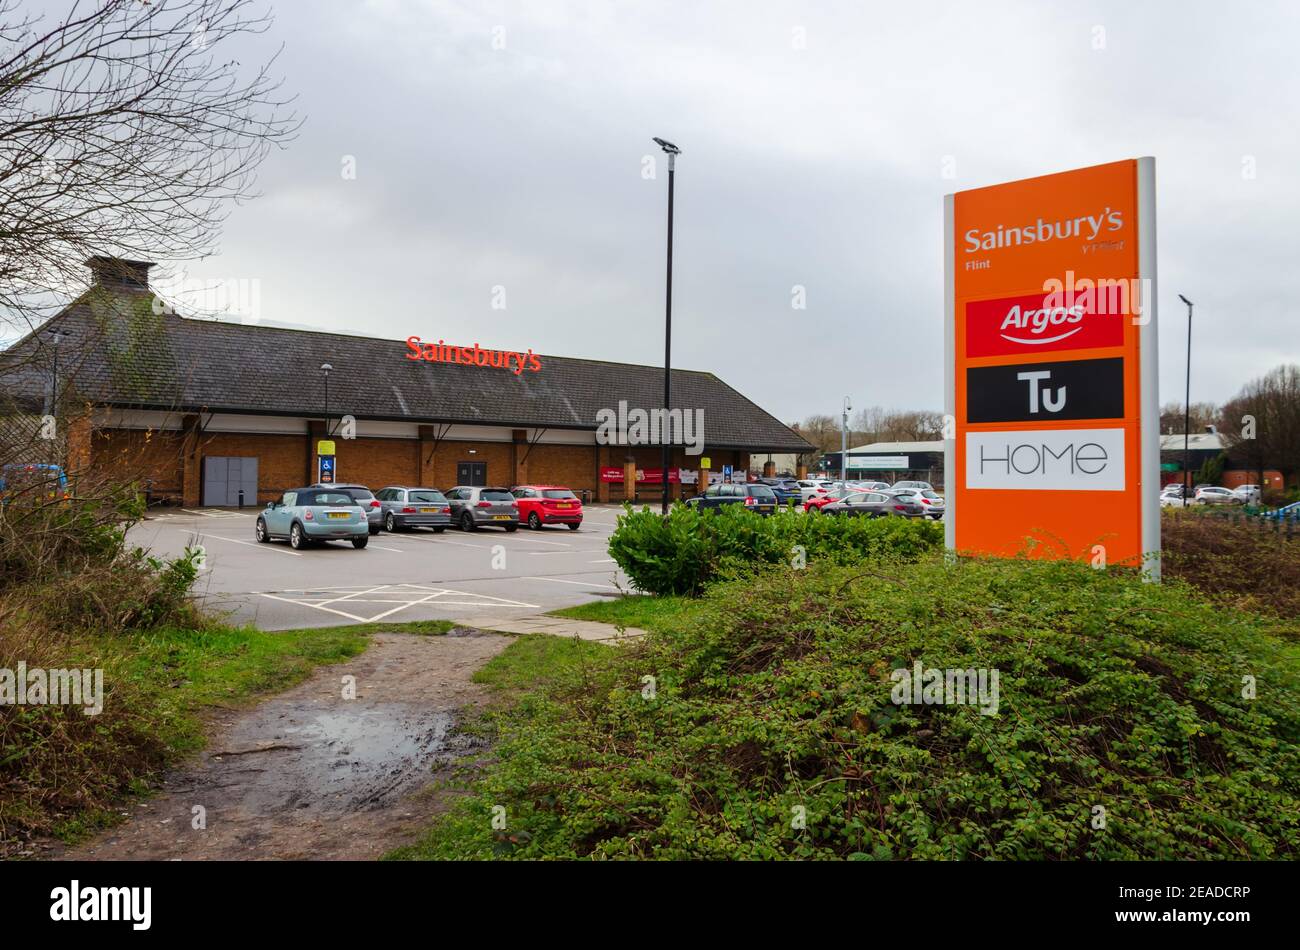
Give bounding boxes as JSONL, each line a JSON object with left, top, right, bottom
{"left": 157, "top": 0, "right": 1300, "bottom": 421}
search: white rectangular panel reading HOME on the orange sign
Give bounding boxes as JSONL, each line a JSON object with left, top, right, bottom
{"left": 966, "top": 429, "right": 1125, "bottom": 491}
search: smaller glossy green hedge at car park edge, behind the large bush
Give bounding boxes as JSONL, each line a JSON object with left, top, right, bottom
{"left": 610, "top": 504, "right": 944, "bottom": 594}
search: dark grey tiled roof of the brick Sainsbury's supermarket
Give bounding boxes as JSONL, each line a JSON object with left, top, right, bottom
{"left": 0, "top": 290, "right": 813, "bottom": 452}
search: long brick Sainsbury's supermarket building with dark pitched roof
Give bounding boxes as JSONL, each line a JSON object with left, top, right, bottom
{"left": 0, "top": 257, "right": 813, "bottom": 507}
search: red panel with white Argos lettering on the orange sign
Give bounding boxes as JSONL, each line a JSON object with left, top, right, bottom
{"left": 966, "top": 294, "right": 1125, "bottom": 356}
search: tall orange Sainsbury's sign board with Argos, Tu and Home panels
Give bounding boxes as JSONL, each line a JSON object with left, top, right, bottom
{"left": 945, "top": 159, "right": 1160, "bottom": 571}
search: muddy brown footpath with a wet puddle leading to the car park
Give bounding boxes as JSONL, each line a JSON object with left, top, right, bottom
{"left": 52, "top": 629, "right": 510, "bottom": 860}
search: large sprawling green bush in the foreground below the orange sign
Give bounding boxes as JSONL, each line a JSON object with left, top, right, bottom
{"left": 411, "top": 558, "right": 1300, "bottom": 860}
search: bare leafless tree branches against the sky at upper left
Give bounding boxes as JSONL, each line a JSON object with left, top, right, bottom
{"left": 0, "top": 0, "right": 298, "bottom": 343}
